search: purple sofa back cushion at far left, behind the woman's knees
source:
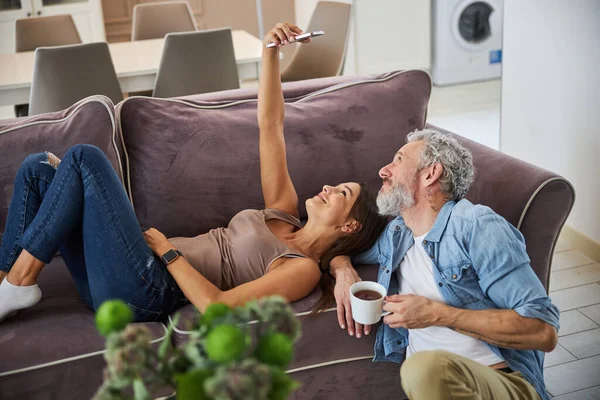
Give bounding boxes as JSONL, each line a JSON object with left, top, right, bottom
{"left": 0, "top": 96, "right": 123, "bottom": 239}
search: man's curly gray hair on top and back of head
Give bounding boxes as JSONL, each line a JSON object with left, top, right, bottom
{"left": 406, "top": 129, "right": 475, "bottom": 201}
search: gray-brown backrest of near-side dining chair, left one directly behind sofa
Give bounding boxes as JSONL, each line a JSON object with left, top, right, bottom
{"left": 29, "top": 42, "right": 123, "bottom": 115}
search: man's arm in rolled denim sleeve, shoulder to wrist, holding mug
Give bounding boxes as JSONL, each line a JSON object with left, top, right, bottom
{"left": 466, "top": 212, "right": 559, "bottom": 351}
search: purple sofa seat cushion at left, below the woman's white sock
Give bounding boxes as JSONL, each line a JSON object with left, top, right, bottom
{"left": 0, "top": 257, "right": 166, "bottom": 399}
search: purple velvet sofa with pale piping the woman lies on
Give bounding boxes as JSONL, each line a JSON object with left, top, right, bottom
{"left": 0, "top": 71, "right": 574, "bottom": 399}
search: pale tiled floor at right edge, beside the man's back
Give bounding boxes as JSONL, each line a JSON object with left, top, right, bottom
{"left": 544, "top": 242, "right": 600, "bottom": 400}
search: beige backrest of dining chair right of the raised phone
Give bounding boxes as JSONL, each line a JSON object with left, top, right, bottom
{"left": 281, "top": 1, "right": 352, "bottom": 82}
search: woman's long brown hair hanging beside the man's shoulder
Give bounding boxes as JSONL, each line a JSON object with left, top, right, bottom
{"left": 313, "top": 183, "right": 387, "bottom": 314}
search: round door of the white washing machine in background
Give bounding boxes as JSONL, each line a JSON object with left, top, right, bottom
{"left": 450, "top": 0, "right": 502, "bottom": 51}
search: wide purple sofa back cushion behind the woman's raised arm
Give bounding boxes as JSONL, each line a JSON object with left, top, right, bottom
{"left": 117, "top": 71, "right": 431, "bottom": 237}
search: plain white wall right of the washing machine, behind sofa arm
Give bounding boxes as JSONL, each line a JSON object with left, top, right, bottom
{"left": 500, "top": 0, "right": 600, "bottom": 243}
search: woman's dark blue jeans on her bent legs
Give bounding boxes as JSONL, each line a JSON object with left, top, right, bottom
{"left": 0, "top": 145, "right": 188, "bottom": 322}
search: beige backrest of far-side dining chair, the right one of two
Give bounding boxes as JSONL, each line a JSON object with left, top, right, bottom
{"left": 131, "top": 1, "right": 198, "bottom": 40}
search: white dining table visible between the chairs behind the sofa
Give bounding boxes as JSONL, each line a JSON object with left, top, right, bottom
{"left": 0, "top": 30, "right": 270, "bottom": 106}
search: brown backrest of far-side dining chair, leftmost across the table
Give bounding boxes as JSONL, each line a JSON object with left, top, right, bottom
{"left": 15, "top": 15, "right": 81, "bottom": 52}
